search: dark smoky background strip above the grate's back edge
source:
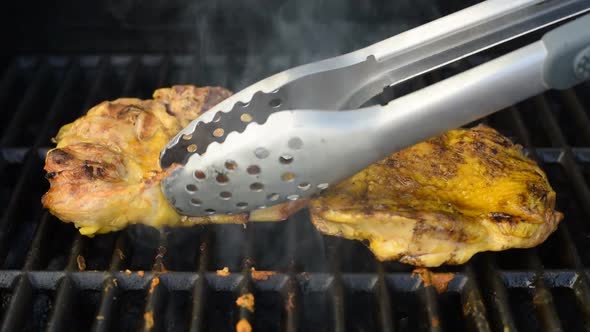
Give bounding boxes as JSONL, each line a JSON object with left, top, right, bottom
{"left": 0, "top": 0, "right": 478, "bottom": 54}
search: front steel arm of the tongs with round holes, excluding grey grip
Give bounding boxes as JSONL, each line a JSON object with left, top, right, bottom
{"left": 164, "top": 42, "right": 547, "bottom": 215}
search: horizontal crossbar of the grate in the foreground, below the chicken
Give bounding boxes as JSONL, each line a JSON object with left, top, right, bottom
{"left": 1, "top": 272, "right": 590, "bottom": 294}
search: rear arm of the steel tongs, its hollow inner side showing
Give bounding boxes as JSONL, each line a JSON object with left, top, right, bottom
{"left": 160, "top": 0, "right": 590, "bottom": 167}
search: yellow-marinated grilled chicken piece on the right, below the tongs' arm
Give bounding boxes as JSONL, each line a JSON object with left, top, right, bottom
{"left": 311, "top": 125, "right": 563, "bottom": 267}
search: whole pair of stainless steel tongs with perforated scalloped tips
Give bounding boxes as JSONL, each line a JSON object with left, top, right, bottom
{"left": 160, "top": 0, "right": 590, "bottom": 216}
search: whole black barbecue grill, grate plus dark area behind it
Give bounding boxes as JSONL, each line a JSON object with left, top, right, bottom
{"left": 0, "top": 0, "right": 590, "bottom": 331}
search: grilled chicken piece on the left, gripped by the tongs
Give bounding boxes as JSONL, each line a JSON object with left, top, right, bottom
{"left": 42, "top": 86, "right": 305, "bottom": 235}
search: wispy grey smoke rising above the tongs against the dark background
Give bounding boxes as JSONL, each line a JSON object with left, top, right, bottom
{"left": 194, "top": 0, "right": 434, "bottom": 90}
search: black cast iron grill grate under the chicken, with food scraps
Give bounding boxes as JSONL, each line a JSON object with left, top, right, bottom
{"left": 0, "top": 47, "right": 590, "bottom": 331}
